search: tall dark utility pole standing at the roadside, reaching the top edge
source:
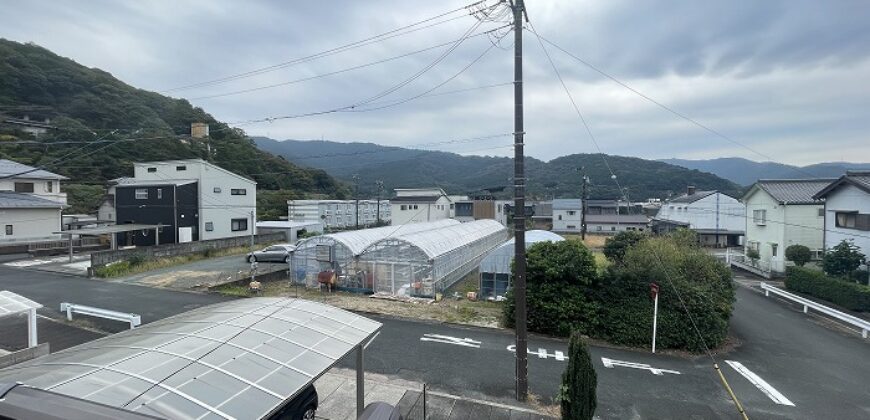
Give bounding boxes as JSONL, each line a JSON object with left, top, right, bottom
{"left": 510, "top": 0, "right": 529, "bottom": 401}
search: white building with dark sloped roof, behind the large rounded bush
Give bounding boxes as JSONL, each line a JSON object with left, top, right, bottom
{"left": 652, "top": 186, "right": 746, "bottom": 247}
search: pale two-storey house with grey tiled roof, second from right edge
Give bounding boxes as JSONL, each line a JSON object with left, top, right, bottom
{"left": 740, "top": 179, "right": 833, "bottom": 273}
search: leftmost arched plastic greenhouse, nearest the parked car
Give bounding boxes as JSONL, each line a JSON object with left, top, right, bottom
{"left": 291, "top": 219, "right": 459, "bottom": 292}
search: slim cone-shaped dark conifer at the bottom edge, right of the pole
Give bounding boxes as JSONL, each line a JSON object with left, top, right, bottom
{"left": 559, "top": 332, "right": 598, "bottom": 420}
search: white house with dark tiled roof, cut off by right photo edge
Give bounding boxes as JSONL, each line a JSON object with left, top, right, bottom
{"left": 815, "top": 171, "right": 870, "bottom": 255}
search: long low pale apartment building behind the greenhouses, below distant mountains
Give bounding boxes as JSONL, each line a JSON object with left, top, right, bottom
{"left": 287, "top": 200, "right": 392, "bottom": 229}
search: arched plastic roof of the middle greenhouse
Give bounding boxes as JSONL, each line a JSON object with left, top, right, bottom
{"left": 378, "top": 220, "right": 506, "bottom": 258}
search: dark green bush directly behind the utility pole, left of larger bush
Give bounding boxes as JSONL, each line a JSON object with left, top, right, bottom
{"left": 504, "top": 241, "right": 598, "bottom": 336}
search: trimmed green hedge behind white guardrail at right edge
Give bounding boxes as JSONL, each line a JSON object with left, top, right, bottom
{"left": 785, "top": 267, "right": 870, "bottom": 312}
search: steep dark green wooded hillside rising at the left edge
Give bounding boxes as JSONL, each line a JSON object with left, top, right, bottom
{"left": 0, "top": 39, "right": 346, "bottom": 208}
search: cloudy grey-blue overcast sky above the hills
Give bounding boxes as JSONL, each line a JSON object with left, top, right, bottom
{"left": 0, "top": 0, "right": 870, "bottom": 164}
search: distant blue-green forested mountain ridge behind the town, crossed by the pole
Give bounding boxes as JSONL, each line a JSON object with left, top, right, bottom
{"left": 254, "top": 137, "right": 741, "bottom": 200}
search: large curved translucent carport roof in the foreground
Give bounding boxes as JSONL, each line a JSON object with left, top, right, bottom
{"left": 0, "top": 298, "right": 381, "bottom": 419}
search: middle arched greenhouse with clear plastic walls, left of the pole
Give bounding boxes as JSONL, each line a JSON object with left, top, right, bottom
{"left": 358, "top": 220, "right": 507, "bottom": 297}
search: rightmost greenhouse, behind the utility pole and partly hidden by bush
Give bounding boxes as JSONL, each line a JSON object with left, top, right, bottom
{"left": 480, "top": 230, "right": 565, "bottom": 299}
